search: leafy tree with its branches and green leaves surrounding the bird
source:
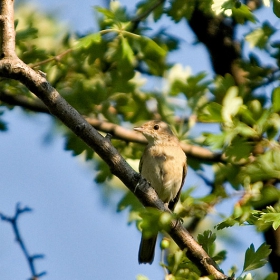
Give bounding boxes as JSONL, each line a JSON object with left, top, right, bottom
{"left": 0, "top": 0, "right": 280, "bottom": 280}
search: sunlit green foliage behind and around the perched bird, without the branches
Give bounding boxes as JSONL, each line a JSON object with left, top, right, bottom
{"left": 0, "top": 0, "right": 280, "bottom": 279}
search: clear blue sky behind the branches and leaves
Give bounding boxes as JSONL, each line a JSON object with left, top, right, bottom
{"left": 0, "top": 0, "right": 274, "bottom": 280}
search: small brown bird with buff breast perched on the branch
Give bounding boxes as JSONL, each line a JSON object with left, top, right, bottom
{"left": 134, "top": 121, "right": 187, "bottom": 264}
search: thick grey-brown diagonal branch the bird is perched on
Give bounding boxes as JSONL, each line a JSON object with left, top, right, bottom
{"left": 0, "top": 0, "right": 230, "bottom": 279}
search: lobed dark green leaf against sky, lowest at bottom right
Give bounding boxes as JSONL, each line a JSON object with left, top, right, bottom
{"left": 243, "top": 243, "right": 271, "bottom": 272}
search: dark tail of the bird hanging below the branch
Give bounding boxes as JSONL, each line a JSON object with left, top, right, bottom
{"left": 138, "top": 234, "right": 157, "bottom": 264}
